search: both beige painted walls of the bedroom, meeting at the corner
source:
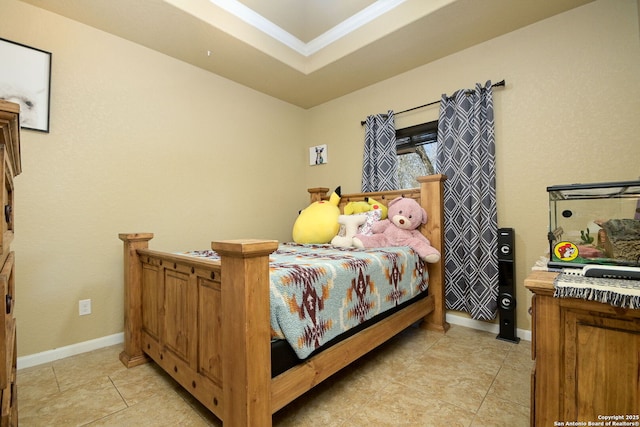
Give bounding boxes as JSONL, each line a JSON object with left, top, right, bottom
{"left": 5, "top": 0, "right": 640, "bottom": 356}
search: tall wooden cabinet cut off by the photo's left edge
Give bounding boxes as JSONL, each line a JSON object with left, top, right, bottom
{"left": 0, "top": 100, "right": 22, "bottom": 427}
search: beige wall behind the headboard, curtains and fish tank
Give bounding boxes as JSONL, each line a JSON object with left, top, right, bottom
{"left": 303, "top": 0, "right": 640, "bottom": 329}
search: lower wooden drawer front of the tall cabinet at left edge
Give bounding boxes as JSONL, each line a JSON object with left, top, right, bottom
{"left": 0, "top": 252, "right": 16, "bottom": 389}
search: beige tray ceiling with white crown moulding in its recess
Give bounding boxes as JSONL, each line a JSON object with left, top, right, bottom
{"left": 22, "top": 0, "right": 593, "bottom": 108}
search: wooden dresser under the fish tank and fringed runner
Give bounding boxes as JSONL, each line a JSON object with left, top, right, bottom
{"left": 525, "top": 271, "right": 640, "bottom": 427}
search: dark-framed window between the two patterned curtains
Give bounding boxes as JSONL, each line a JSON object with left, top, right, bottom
{"left": 396, "top": 120, "right": 438, "bottom": 188}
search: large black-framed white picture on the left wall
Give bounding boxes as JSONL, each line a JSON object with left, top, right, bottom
{"left": 0, "top": 38, "right": 51, "bottom": 132}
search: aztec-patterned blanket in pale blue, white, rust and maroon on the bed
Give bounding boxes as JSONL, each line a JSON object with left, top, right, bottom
{"left": 188, "top": 243, "right": 429, "bottom": 359}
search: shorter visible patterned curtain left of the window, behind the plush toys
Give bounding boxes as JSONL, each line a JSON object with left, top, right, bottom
{"left": 362, "top": 110, "right": 398, "bottom": 192}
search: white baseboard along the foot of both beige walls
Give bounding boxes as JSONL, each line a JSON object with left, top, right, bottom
{"left": 17, "top": 313, "right": 531, "bottom": 369}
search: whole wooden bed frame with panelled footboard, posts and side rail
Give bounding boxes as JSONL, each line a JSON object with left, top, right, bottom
{"left": 119, "top": 175, "right": 449, "bottom": 427}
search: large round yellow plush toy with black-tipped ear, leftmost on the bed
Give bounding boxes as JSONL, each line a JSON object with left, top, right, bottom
{"left": 293, "top": 187, "right": 340, "bottom": 243}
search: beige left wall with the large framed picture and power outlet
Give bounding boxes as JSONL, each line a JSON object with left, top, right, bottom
{"left": 0, "top": 0, "right": 308, "bottom": 356}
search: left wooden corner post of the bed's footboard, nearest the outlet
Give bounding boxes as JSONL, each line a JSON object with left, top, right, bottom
{"left": 118, "top": 233, "right": 153, "bottom": 368}
